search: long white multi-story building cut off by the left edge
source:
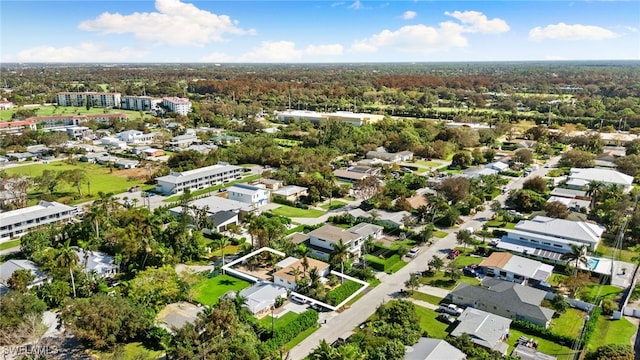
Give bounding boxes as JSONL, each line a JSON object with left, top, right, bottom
{"left": 0, "top": 201, "right": 77, "bottom": 243}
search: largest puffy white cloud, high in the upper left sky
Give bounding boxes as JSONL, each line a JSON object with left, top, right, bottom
{"left": 78, "top": 0, "right": 255, "bottom": 46}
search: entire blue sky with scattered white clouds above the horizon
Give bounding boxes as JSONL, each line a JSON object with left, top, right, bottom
{"left": 0, "top": 0, "right": 640, "bottom": 63}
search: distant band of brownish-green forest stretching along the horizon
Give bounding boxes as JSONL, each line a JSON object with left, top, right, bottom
{"left": 0, "top": 61, "right": 640, "bottom": 130}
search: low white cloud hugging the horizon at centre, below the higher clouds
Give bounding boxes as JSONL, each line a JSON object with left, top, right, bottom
{"left": 210, "top": 41, "right": 344, "bottom": 62}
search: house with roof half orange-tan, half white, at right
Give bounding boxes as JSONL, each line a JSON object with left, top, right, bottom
{"left": 480, "top": 252, "right": 553, "bottom": 284}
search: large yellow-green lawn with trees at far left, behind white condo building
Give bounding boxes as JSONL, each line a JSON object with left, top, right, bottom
{"left": 5, "top": 161, "right": 144, "bottom": 203}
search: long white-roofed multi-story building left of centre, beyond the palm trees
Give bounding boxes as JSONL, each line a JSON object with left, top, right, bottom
{"left": 156, "top": 164, "right": 243, "bottom": 194}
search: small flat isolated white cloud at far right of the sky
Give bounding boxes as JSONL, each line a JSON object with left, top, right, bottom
{"left": 529, "top": 23, "right": 618, "bottom": 41}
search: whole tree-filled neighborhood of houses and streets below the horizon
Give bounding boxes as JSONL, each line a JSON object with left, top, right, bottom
{"left": 0, "top": 64, "right": 640, "bottom": 360}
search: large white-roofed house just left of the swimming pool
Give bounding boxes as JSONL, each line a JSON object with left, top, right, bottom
{"left": 498, "top": 216, "right": 605, "bottom": 260}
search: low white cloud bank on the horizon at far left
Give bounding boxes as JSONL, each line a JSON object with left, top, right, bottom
{"left": 3, "top": 42, "right": 147, "bottom": 62}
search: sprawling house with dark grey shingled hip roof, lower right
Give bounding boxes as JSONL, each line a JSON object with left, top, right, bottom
{"left": 445, "top": 277, "right": 554, "bottom": 328}
